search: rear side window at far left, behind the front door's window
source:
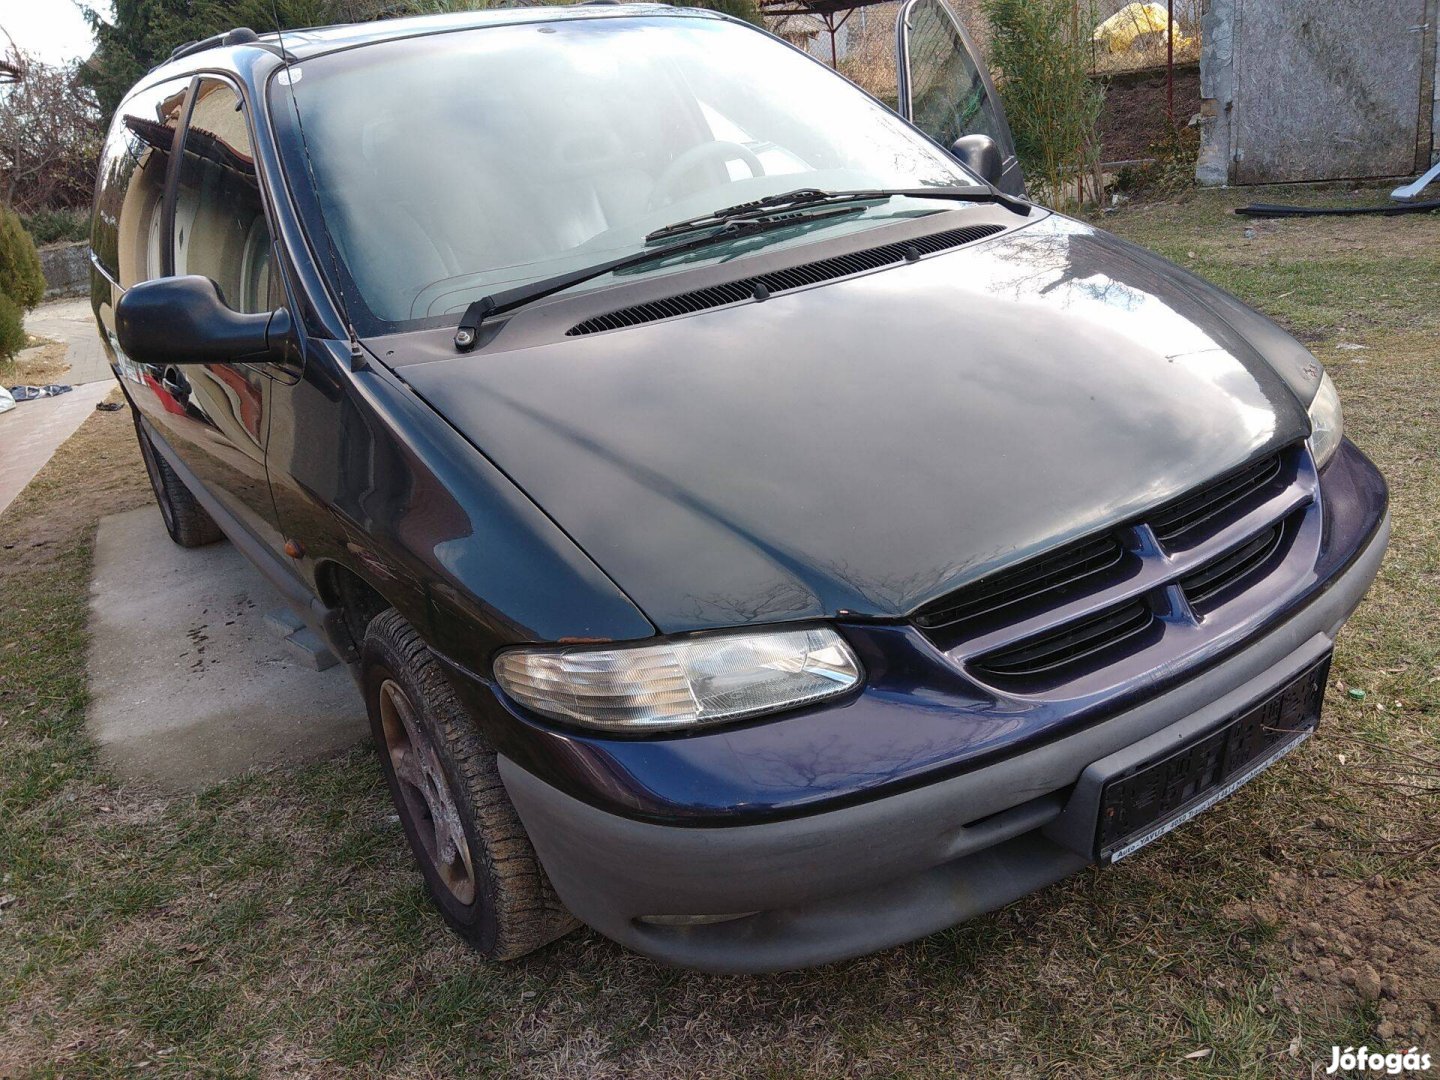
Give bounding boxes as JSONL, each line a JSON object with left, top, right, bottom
{"left": 91, "top": 78, "right": 190, "bottom": 288}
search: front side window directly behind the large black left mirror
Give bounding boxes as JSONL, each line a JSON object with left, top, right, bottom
{"left": 173, "top": 79, "right": 281, "bottom": 312}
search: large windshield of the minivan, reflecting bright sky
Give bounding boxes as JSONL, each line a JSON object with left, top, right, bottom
{"left": 271, "top": 16, "right": 975, "bottom": 333}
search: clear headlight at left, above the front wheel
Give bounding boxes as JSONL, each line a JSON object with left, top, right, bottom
{"left": 495, "top": 628, "right": 861, "bottom": 732}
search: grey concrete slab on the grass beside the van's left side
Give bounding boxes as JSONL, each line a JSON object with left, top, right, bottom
{"left": 89, "top": 507, "right": 369, "bottom": 791}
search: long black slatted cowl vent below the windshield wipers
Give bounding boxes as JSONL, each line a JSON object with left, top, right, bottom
{"left": 564, "top": 225, "right": 1005, "bottom": 337}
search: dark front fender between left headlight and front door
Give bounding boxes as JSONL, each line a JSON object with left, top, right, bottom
{"left": 269, "top": 341, "right": 654, "bottom": 672}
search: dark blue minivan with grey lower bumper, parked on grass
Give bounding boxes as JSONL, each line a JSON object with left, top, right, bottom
{"left": 92, "top": 0, "right": 1390, "bottom": 972}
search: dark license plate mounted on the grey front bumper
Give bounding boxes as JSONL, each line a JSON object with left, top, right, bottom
{"left": 1094, "top": 657, "right": 1331, "bottom": 863}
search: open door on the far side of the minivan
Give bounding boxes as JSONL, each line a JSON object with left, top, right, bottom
{"left": 896, "top": 0, "right": 1025, "bottom": 196}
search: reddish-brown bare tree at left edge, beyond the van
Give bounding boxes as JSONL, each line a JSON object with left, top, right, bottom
{"left": 0, "top": 53, "right": 104, "bottom": 212}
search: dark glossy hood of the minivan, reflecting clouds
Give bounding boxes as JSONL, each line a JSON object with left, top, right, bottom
{"left": 403, "top": 216, "right": 1319, "bottom": 632}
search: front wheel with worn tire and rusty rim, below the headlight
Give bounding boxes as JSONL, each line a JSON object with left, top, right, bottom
{"left": 360, "top": 608, "right": 577, "bottom": 960}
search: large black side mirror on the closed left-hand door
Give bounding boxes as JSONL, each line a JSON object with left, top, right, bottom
{"left": 115, "top": 274, "right": 291, "bottom": 367}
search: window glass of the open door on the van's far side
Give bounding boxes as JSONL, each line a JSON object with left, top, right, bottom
{"left": 906, "top": 3, "right": 1009, "bottom": 147}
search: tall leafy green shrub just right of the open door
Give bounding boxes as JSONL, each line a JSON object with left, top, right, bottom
{"left": 982, "top": 0, "right": 1104, "bottom": 203}
